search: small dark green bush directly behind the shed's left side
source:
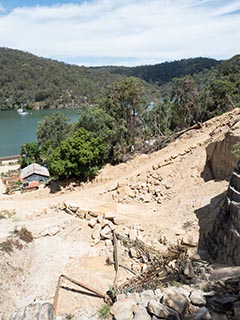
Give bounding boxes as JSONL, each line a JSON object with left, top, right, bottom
{"left": 20, "top": 142, "right": 40, "bottom": 168}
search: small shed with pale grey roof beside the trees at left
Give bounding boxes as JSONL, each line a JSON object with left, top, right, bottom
{"left": 20, "top": 163, "right": 50, "bottom": 183}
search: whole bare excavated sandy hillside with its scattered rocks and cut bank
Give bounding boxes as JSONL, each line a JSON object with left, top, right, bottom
{"left": 0, "top": 109, "right": 240, "bottom": 320}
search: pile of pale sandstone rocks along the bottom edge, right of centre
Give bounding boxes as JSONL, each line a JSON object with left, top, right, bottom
{"left": 111, "top": 287, "right": 212, "bottom": 320}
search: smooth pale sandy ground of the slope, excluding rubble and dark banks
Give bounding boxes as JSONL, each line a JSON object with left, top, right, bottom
{"left": 0, "top": 109, "right": 239, "bottom": 314}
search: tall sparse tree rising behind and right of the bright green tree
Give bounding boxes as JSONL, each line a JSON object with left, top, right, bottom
{"left": 100, "top": 77, "right": 144, "bottom": 163}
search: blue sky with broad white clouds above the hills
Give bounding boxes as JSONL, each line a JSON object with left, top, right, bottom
{"left": 0, "top": 0, "right": 240, "bottom": 66}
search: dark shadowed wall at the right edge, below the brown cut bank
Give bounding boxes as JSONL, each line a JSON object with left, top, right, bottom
{"left": 204, "top": 163, "right": 240, "bottom": 265}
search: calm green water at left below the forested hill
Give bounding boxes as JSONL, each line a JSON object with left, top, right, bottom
{"left": 0, "top": 109, "right": 79, "bottom": 157}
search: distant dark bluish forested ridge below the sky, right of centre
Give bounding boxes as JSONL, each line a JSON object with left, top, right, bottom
{"left": 95, "top": 58, "right": 221, "bottom": 86}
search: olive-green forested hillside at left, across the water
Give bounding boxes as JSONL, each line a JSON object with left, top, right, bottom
{"left": 0, "top": 48, "right": 159, "bottom": 110}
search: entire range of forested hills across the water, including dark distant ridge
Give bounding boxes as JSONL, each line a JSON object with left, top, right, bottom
{"left": 0, "top": 48, "right": 219, "bottom": 110}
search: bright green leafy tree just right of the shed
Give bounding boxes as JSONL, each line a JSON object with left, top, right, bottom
{"left": 47, "top": 128, "right": 106, "bottom": 181}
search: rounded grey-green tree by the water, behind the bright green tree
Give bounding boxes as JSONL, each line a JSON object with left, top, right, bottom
{"left": 37, "top": 112, "right": 71, "bottom": 152}
